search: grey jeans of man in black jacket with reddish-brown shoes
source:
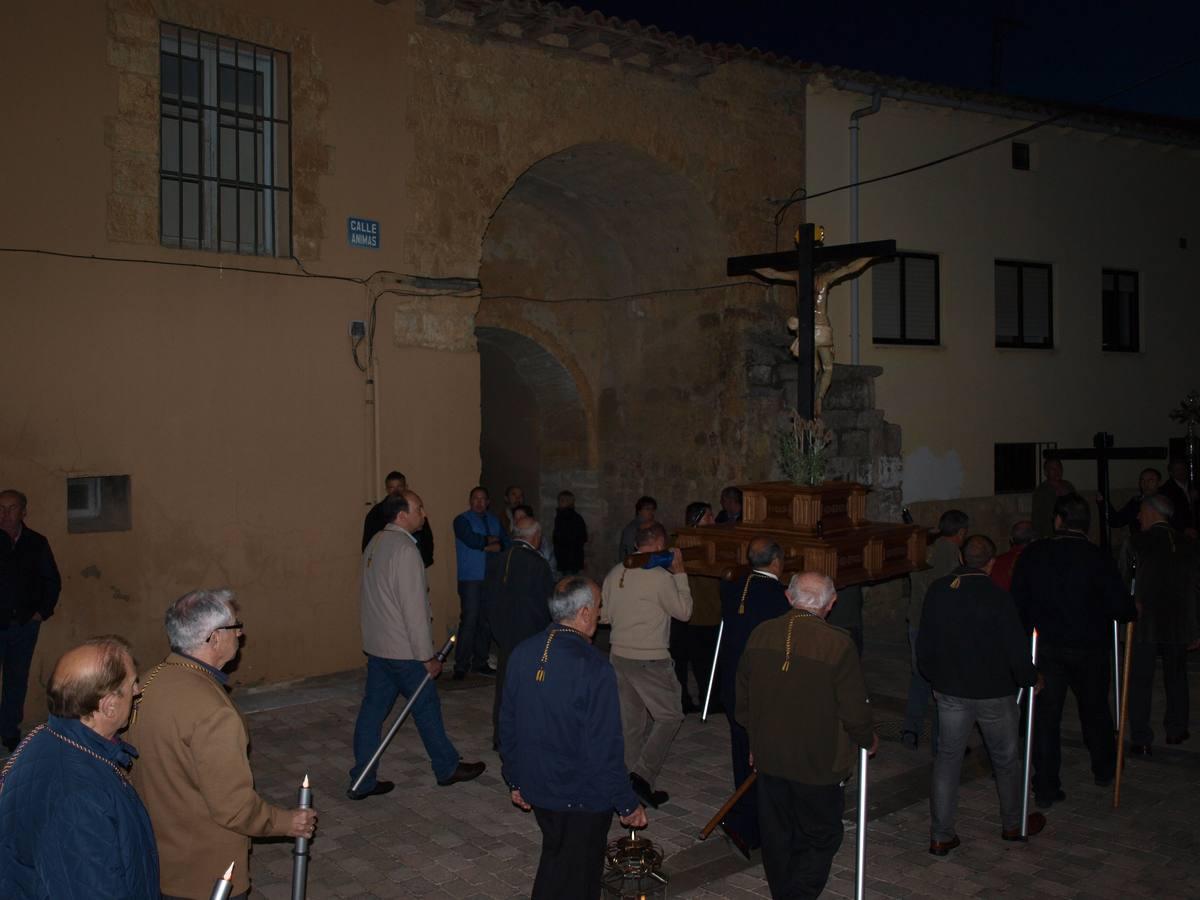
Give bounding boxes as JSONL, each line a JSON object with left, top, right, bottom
{"left": 929, "top": 691, "right": 1025, "bottom": 842}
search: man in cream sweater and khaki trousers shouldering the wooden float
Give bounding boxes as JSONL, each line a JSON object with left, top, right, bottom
{"left": 600, "top": 522, "right": 691, "bottom": 809}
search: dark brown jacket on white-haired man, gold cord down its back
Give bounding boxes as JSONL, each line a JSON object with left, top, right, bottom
{"left": 736, "top": 610, "right": 874, "bottom": 785}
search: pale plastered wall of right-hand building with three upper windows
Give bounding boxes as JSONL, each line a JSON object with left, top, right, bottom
{"left": 808, "top": 79, "right": 1200, "bottom": 500}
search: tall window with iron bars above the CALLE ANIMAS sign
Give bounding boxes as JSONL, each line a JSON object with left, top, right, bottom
{"left": 158, "top": 24, "right": 292, "bottom": 257}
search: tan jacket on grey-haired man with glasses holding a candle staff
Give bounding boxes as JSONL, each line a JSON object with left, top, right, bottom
{"left": 126, "top": 653, "right": 292, "bottom": 900}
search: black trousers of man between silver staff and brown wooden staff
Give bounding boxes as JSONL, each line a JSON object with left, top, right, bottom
{"left": 1033, "top": 646, "right": 1117, "bottom": 797}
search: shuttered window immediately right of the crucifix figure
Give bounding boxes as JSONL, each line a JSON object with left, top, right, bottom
{"left": 871, "top": 253, "right": 941, "bottom": 344}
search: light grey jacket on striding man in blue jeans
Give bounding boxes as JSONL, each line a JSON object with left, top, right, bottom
{"left": 359, "top": 523, "right": 433, "bottom": 660}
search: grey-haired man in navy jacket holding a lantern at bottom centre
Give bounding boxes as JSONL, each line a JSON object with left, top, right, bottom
{"left": 500, "top": 576, "right": 646, "bottom": 900}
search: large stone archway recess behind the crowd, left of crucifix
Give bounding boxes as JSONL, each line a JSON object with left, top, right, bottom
{"left": 476, "top": 143, "right": 744, "bottom": 564}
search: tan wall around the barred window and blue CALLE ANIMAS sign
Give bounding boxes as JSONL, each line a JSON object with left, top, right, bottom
{"left": 0, "top": 0, "right": 803, "bottom": 716}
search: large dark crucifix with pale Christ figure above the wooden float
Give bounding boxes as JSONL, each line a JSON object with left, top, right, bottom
{"left": 725, "top": 223, "right": 896, "bottom": 419}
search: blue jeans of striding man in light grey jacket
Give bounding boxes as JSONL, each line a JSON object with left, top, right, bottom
{"left": 350, "top": 654, "right": 458, "bottom": 792}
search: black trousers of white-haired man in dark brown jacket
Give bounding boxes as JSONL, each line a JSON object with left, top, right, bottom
{"left": 756, "top": 772, "right": 846, "bottom": 900}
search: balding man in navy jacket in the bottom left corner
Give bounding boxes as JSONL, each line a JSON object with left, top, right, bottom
{"left": 0, "top": 636, "right": 159, "bottom": 900}
